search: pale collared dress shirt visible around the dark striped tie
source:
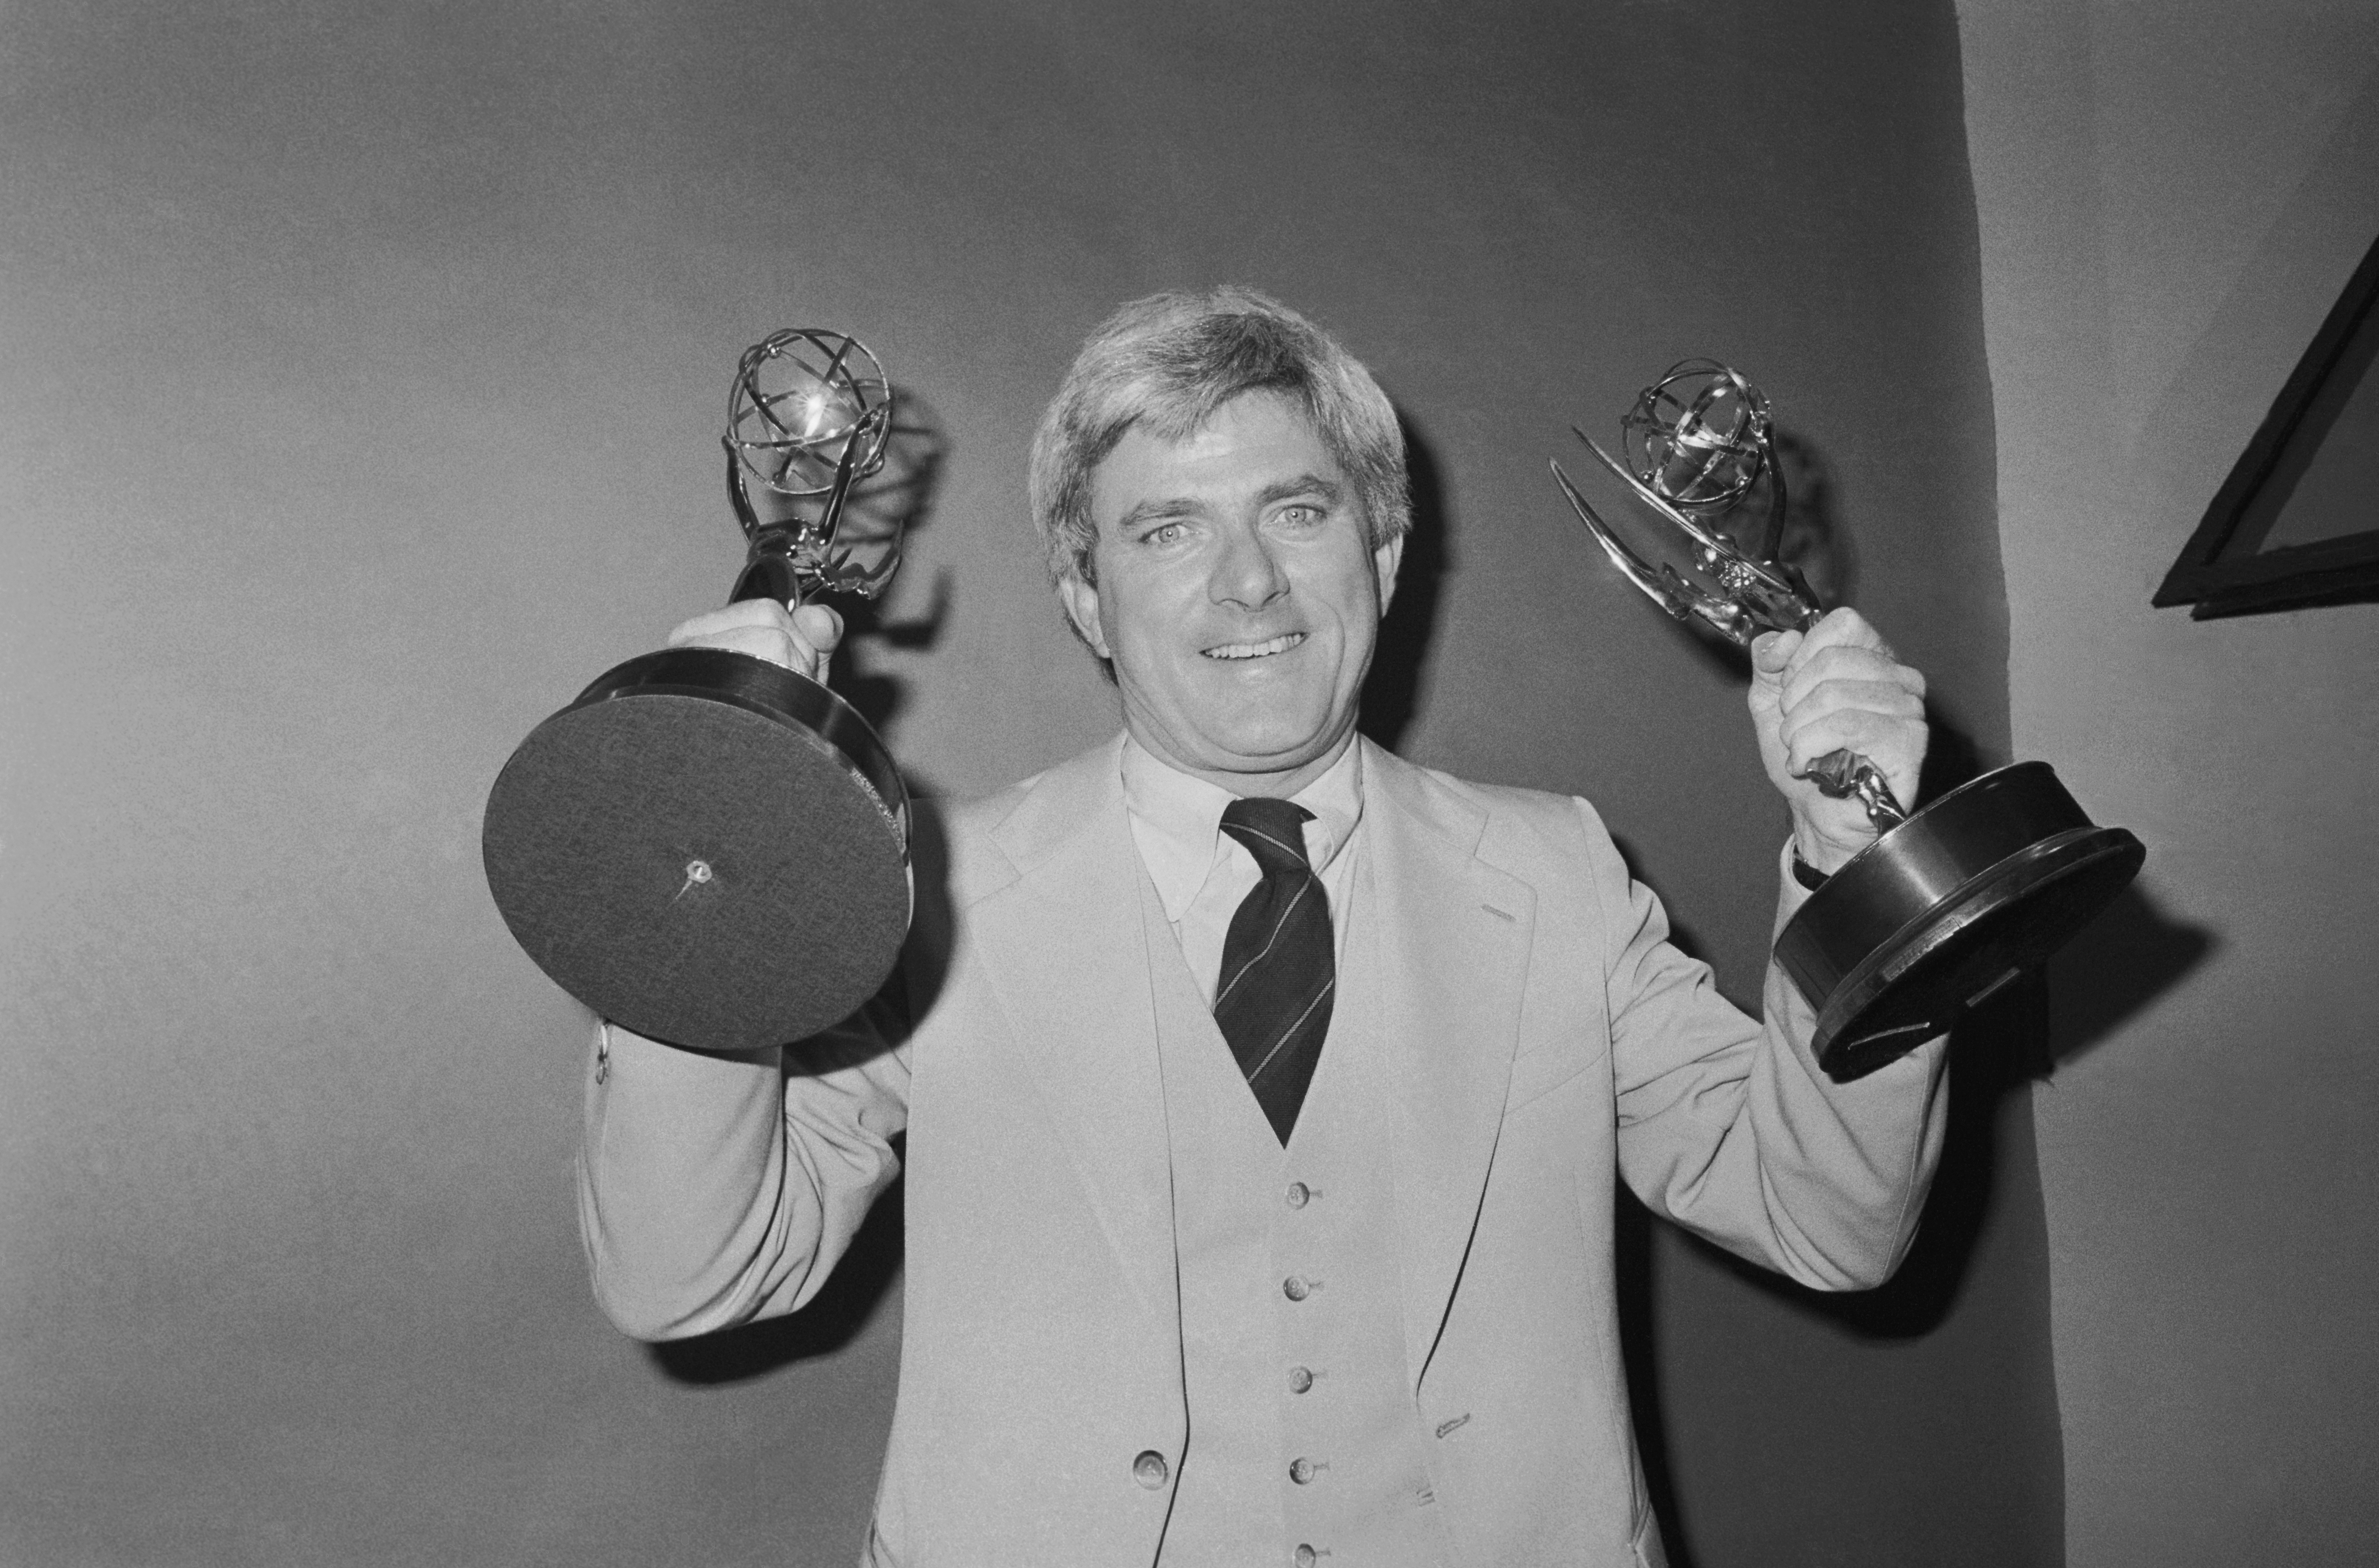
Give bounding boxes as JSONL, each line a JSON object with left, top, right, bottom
{"left": 1123, "top": 740, "right": 1363, "bottom": 1007}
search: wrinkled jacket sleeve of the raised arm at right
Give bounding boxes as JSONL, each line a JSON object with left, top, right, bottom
{"left": 1580, "top": 802, "right": 1946, "bottom": 1290}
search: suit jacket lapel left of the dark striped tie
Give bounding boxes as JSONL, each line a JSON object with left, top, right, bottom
{"left": 966, "top": 745, "right": 1180, "bottom": 1325}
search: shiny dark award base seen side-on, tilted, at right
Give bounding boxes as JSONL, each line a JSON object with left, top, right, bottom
{"left": 1775, "top": 761, "right": 2148, "bottom": 1083}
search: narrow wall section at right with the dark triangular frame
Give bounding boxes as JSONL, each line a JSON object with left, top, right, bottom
{"left": 1960, "top": 0, "right": 2379, "bottom": 1568}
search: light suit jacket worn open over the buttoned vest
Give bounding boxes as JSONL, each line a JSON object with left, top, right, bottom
{"left": 583, "top": 742, "right": 1944, "bottom": 1568}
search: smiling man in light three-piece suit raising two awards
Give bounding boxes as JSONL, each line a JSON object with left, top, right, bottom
{"left": 583, "top": 290, "right": 1941, "bottom": 1568}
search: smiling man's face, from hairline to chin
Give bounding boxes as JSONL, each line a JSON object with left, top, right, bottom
{"left": 1058, "top": 392, "right": 1404, "bottom": 795}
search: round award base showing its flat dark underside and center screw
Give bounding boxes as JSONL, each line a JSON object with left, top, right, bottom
{"left": 481, "top": 647, "right": 909, "bottom": 1052}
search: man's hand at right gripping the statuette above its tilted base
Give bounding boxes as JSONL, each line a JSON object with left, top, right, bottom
{"left": 1751, "top": 609, "right": 1929, "bottom": 871}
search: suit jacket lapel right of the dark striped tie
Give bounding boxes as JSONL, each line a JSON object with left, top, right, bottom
{"left": 1349, "top": 742, "right": 1537, "bottom": 1385}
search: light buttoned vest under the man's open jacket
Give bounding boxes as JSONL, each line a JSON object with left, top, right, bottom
{"left": 1142, "top": 866, "right": 1451, "bottom": 1568}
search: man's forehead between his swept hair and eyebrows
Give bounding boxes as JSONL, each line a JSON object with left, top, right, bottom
{"left": 1089, "top": 392, "right": 1346, "bottom": 523}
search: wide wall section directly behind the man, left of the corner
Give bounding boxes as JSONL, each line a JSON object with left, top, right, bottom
{"left": 0, "top": 0, "right": 2058, "bottom": 1566}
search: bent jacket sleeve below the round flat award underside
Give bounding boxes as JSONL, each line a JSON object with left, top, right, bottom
{"left": 578, "top": 1002, "right": 909, "bottom": 1340}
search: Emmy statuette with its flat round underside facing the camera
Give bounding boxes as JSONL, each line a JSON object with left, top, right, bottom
{"left": 481, "top": 329, "right": 911, "bottom": 1052}
